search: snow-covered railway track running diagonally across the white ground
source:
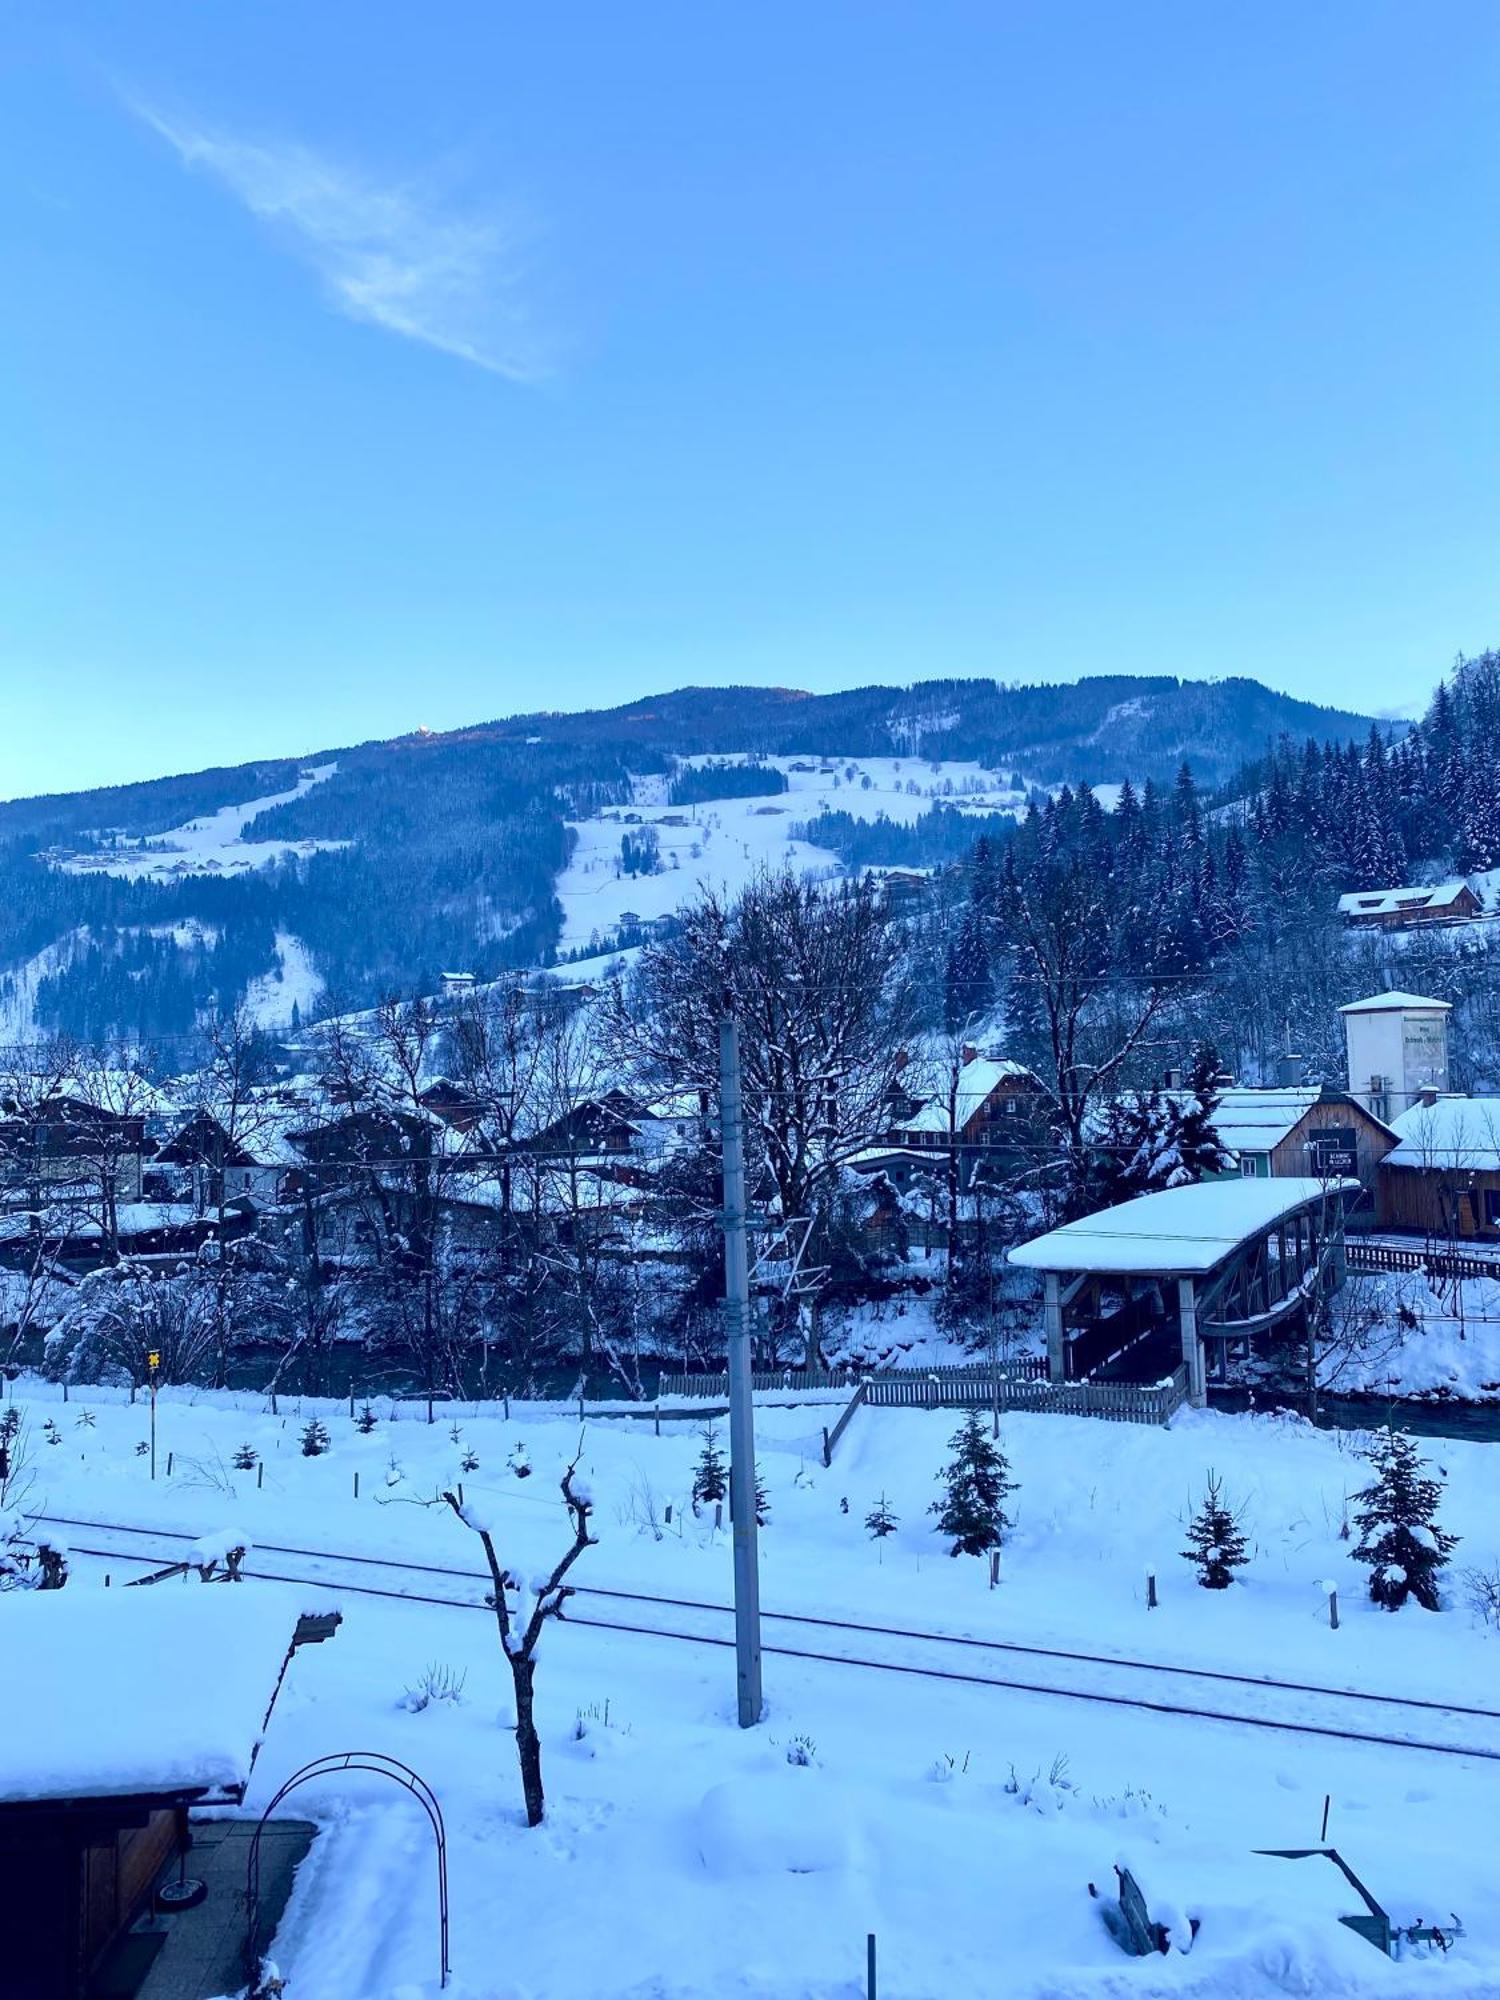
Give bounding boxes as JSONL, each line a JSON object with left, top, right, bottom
{"left": 42, "top": 1514, "right": 1500, "bottom": 1762}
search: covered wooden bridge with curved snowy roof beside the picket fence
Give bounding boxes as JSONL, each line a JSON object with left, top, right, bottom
{"left": 1010, "top": 1178, "right": 1360, "bottom": 1406}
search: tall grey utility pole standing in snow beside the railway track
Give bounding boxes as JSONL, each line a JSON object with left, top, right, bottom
{"left": 718, "top": 1008, "right": 760, "bottom": 1730}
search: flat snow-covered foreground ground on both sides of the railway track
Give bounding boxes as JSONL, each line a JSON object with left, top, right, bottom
{"left": 0, "top": 1382, "right": 1500, "bottom": 2000}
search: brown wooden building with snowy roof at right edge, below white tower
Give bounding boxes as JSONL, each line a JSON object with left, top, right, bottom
{"left": 1376, "top": 1090, "right": 1500, "bottom": 1242}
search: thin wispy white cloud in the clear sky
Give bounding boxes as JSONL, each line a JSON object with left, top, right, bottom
{"left": 130, "top": 102, "right": 550, "bottom": 382}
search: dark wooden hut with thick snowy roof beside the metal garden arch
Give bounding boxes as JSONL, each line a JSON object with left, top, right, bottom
{"left": 0, "top": 1580, "right": 338, "bottom": 2000}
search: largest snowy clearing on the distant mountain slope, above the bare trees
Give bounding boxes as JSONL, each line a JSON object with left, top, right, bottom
{"left": 558, "top": 756, "right": 1026, "bottom": 950}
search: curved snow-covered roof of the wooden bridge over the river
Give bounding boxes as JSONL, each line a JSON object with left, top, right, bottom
{"left": 1010, "top": 1176, "right": 1360, "bottom": 1278}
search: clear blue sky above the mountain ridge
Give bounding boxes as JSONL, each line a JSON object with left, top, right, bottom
{"left": 0, "top": 0, "right": 1500, "bottom": 794}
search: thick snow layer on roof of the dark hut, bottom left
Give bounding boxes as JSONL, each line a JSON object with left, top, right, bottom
{"left": 0, "top": 1580, "right": 330, "bottom": 1802}
